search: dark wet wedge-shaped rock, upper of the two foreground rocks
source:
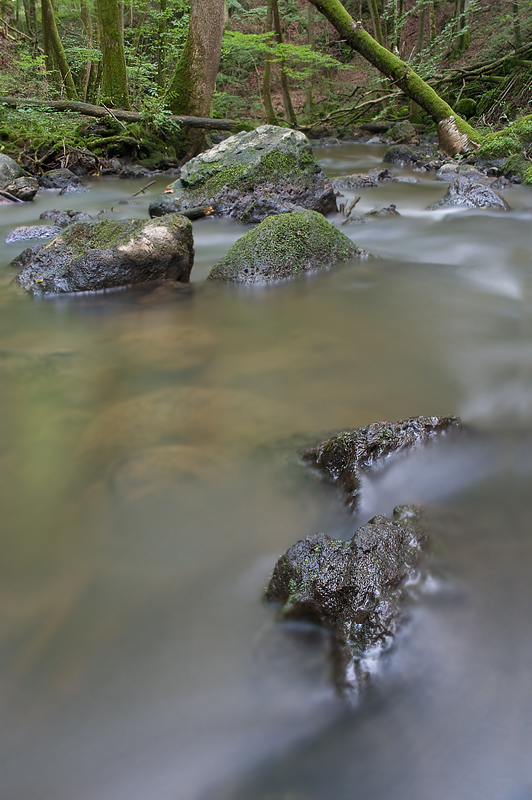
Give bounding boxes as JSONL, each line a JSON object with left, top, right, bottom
{"left": 302, "top": 417, "right": 461, "bottom": 508}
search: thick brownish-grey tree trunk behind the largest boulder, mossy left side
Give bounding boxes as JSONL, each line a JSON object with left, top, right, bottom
{"left": 167, "top": 0, "right": 225, "bottom": 156}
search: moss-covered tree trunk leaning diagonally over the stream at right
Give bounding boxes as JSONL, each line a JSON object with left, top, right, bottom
{"left": 309, "top": 0, "right": 479, "bottom": 142}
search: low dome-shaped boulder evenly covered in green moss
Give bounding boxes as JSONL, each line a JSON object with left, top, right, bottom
{"left": 209, "top": 211, "right": 363, "bottom": 283}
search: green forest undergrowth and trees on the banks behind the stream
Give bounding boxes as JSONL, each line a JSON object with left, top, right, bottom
{"left": 0, "top": 0, "right": 532, "bottom": 167}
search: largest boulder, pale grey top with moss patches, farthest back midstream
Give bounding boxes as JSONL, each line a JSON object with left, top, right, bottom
{"left": 150, "top": 125, "right": 336, "bottom": 222}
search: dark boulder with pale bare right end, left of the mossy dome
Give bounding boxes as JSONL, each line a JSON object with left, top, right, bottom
{"left": 11, "top": 214, "right": 194, "bottom": 295}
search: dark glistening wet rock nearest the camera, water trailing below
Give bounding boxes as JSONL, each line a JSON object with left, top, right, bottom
{"left": 266, "top": 506, "right": 427, "bottom": 693}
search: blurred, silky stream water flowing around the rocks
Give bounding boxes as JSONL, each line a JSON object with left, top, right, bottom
{"left": 0, "top": 145, "right": 532, "bottom": 800}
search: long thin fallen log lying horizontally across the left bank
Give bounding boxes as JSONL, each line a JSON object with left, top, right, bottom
{"left": 0, "top": 97, "right": 239, "bottom": 131}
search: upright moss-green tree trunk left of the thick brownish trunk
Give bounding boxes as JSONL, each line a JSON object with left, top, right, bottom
{"left": 96, "top": 0, "right": 129, "bottom": 109}
